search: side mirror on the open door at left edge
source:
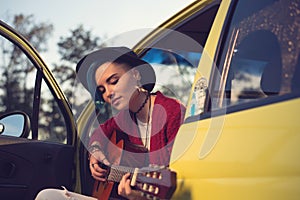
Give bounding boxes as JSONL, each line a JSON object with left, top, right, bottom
{"left": 0, "top": 111, "right": 30, "bottom": 138}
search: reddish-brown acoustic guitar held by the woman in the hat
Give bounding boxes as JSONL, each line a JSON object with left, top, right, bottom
{"left": 92, "top": 132, "right": 176, "bottom": 200}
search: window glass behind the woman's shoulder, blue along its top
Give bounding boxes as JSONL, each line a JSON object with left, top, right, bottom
{"left": 143, "top": 48, "right": 201, "bottom": 105}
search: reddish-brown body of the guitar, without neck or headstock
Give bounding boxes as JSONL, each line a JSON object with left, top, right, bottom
{"left": 92, "top": 131, "right": 148, "bottom": 200}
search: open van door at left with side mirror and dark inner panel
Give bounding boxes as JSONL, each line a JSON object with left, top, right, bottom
{"left": 0, "top": 21, "right": 76, "bottom": 200}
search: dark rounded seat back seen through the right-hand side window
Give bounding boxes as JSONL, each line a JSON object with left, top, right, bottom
{"left": 234, "top": 30, "right": 282, "bottom": 100}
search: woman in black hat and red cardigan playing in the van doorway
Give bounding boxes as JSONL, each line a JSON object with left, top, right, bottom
{"left": 35, "top": 47, "right": 185, "bottom": 199}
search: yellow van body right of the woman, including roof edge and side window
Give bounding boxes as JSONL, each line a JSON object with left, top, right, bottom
{"left": 131, "top": 0, "right": 300, "bottom": 200}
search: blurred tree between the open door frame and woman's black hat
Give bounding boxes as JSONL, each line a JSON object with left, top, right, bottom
{"left": 53, "top": 25, "right": 105, "bottom": 118}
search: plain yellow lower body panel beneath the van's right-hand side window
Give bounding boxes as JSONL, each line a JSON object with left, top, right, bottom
{"left": 171, "top": 99, "right": 300, "bottom": 199}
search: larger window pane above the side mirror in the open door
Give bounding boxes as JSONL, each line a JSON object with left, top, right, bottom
{"left": 0, "top": 36, "right": 35, "bottom": 116}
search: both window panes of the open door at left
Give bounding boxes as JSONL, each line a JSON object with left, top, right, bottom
{"left": 0, "top": 36, "right": 67, "bottom": 143}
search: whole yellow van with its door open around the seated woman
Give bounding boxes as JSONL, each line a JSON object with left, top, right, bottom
{"left": 0, "top": 0, "right": 300, "bottom": 200}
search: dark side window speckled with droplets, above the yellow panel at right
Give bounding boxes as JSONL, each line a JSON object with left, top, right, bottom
{"left": 211, "top": 0, "right": 300, "bottom": 109}
